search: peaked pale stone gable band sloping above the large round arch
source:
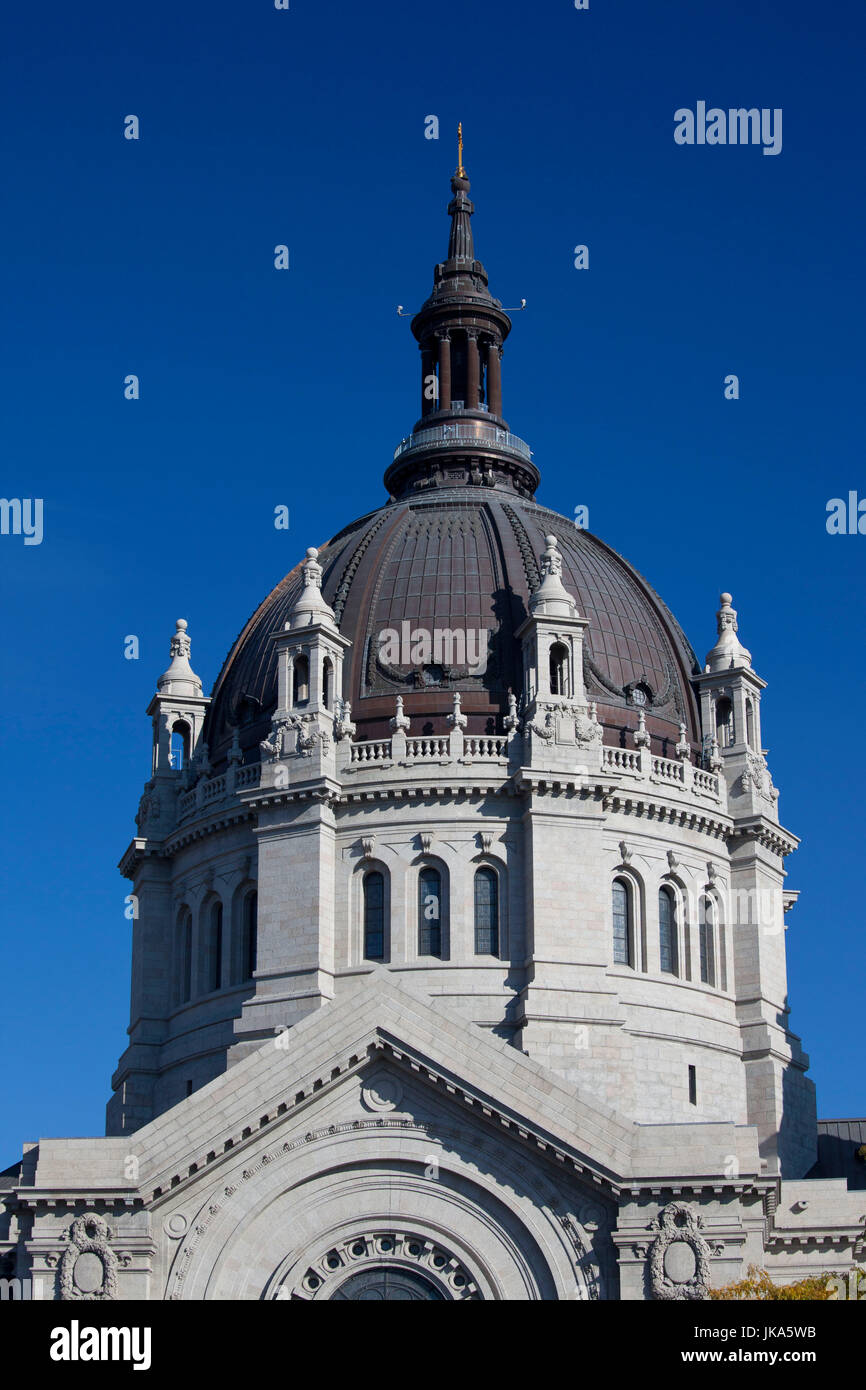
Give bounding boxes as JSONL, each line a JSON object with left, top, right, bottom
{"left": 135, "top": 969, "right": 637, "bottom": 1202}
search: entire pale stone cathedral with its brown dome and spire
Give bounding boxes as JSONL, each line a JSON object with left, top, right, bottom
{"left": 0, "top": 154, "right": 865, "bottom": 1301}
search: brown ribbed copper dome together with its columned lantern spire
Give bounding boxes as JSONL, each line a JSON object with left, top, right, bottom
{"left": 204, "top": 148, "right": 701, "bottom": 765}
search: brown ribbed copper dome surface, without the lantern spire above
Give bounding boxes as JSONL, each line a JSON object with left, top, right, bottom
{"left": 206, "top": 485, "right": 701, "bottom": 763}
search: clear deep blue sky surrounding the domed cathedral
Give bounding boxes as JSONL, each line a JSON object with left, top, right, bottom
{"left": 0, "top": 0, "right": 866, "bottom": 1150}
